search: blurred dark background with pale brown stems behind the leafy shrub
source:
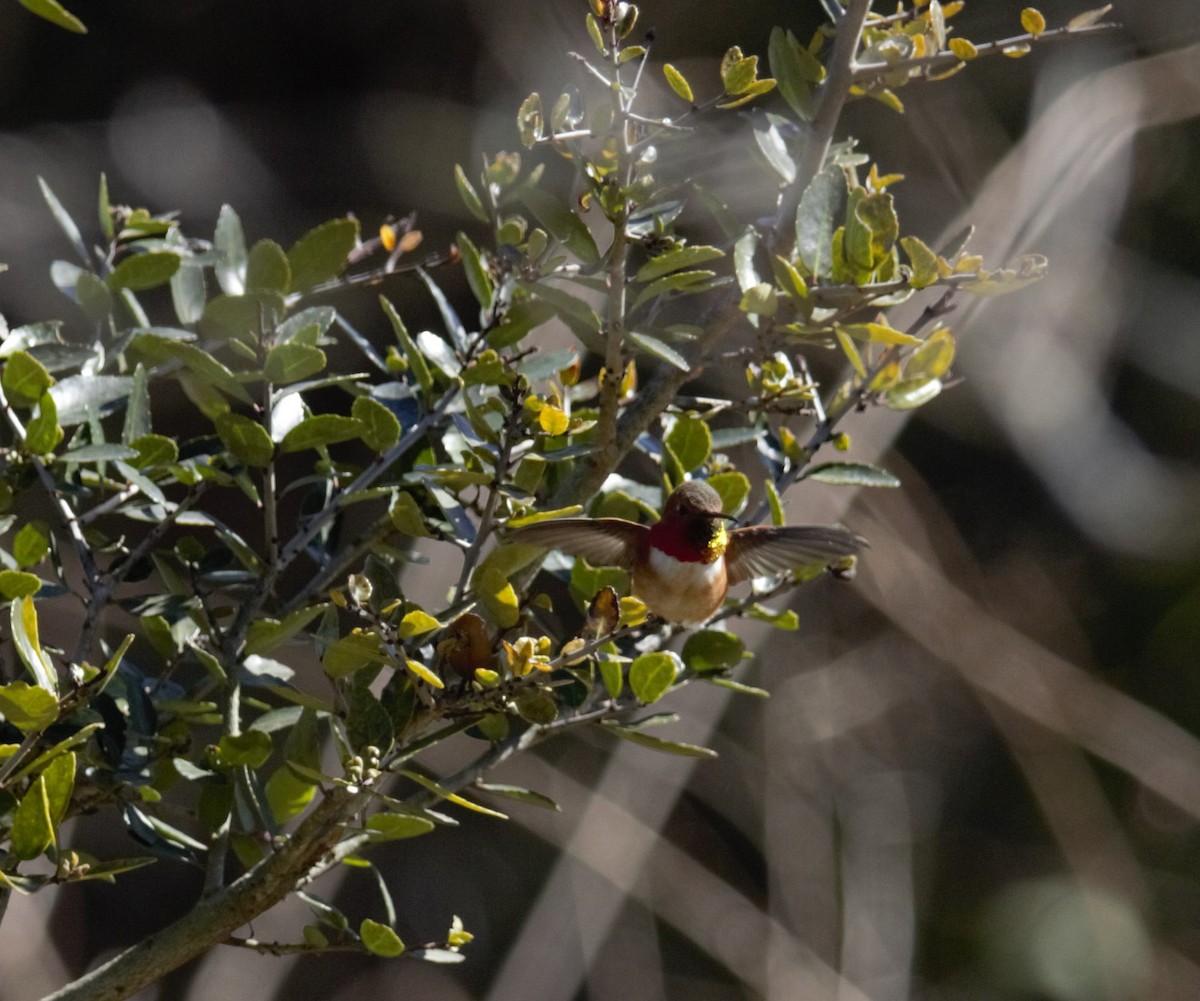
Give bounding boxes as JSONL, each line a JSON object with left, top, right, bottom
{"left": 0, "top": 0, "right": 1200, "bottom": 1001}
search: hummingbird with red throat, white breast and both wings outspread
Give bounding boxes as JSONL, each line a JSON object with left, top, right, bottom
{"left": 508, "top": 480, "right": 866, "bottom": 625}
